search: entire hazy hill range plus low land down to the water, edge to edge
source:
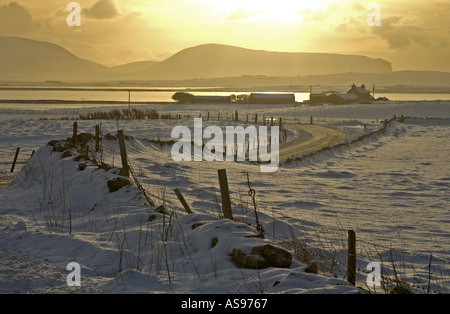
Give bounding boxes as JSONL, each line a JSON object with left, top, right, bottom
{"left": 0, "top": 37, "right": 450, "bottom": 91}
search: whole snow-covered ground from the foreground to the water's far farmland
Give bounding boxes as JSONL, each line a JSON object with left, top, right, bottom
{"left": 0, "top": 101, "right": 450, "bottom": 294}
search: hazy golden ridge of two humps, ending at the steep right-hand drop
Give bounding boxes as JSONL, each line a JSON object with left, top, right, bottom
{"left": 0, "top": 37, "right": 392, "bottom": 81}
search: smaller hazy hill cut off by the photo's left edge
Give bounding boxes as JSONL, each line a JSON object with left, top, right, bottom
{"left": 0, "top": 37, "right": 109, "bottom": 81}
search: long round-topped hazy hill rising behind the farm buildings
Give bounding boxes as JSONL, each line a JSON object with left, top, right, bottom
{"left": 136, "top": 44, "right": 392, "bottom": 80}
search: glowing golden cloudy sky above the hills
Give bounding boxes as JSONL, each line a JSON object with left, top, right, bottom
{"left": 0, "top": 0, "right": 450, "bottom": 72}
